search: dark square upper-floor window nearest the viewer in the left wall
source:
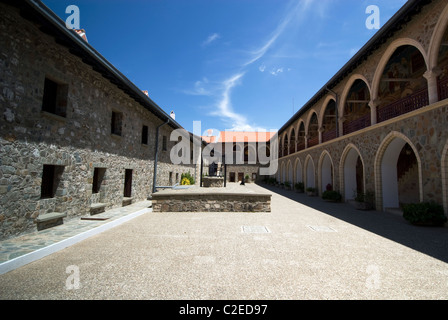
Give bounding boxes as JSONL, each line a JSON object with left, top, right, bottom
{"left": 42, "top": 78, "right": 68, "bottom": 117}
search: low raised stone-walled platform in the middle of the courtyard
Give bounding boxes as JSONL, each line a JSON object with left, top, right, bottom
{"left": 152, "top": 183, "right": 272, "bottom": 212}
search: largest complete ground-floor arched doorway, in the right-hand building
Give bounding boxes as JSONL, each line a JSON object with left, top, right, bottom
{"left": 377, "top": 133, "right": 422, "bottom": 211}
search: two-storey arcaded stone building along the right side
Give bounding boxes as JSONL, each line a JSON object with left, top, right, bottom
{"left": 276, "top": 0, "right": 448, "bottom": 216}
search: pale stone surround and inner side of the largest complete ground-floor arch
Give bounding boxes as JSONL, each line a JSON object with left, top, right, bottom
{"left": 375, "top": 131, "right": 423, "bottom": 211}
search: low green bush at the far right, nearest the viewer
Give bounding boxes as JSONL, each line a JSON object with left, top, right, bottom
{"left": 403, "top": 202, "right": 447, "bottom": 226}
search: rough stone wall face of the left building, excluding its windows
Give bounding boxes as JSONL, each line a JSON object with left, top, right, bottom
{"left": 0, "top": 4, "right": 197, "bottom": 238}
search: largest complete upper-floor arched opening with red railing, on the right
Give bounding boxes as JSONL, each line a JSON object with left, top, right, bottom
{"left": 377, "top": 45, "right": 429, "bottom": 123}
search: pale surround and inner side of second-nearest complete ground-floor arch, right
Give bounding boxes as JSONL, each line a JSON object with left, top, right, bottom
{"left": 339, "top": 143, "right": 366, "bottom": 200}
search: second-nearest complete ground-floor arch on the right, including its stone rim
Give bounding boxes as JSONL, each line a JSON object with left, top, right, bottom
{"left": 339, "top": 143, "right": 366, "bottom": 201}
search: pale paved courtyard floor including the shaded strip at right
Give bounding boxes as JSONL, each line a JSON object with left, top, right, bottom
{"left": 0, "top": 184, "right": 448, "bottom": 300}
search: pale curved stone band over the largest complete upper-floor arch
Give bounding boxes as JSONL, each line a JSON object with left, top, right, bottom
{"left": 370, "top": 38, "right": 428, "bottom": 101}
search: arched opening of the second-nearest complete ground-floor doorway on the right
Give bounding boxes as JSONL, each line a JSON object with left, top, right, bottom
{"left": 343, "top": 147, "right": 365, "bottom": 200}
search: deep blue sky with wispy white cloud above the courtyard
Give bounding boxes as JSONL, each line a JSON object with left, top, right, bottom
{"left": 43, "top": 0, "right": 406, "bottom": 132}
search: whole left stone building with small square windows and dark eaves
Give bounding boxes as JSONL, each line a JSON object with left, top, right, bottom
{"left": 0, "top": 1, "right": 200, "bottom": 238}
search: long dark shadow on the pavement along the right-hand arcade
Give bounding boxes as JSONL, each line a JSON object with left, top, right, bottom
{"left": 260, "top": 184, "right": 448, "bottom": 263}
